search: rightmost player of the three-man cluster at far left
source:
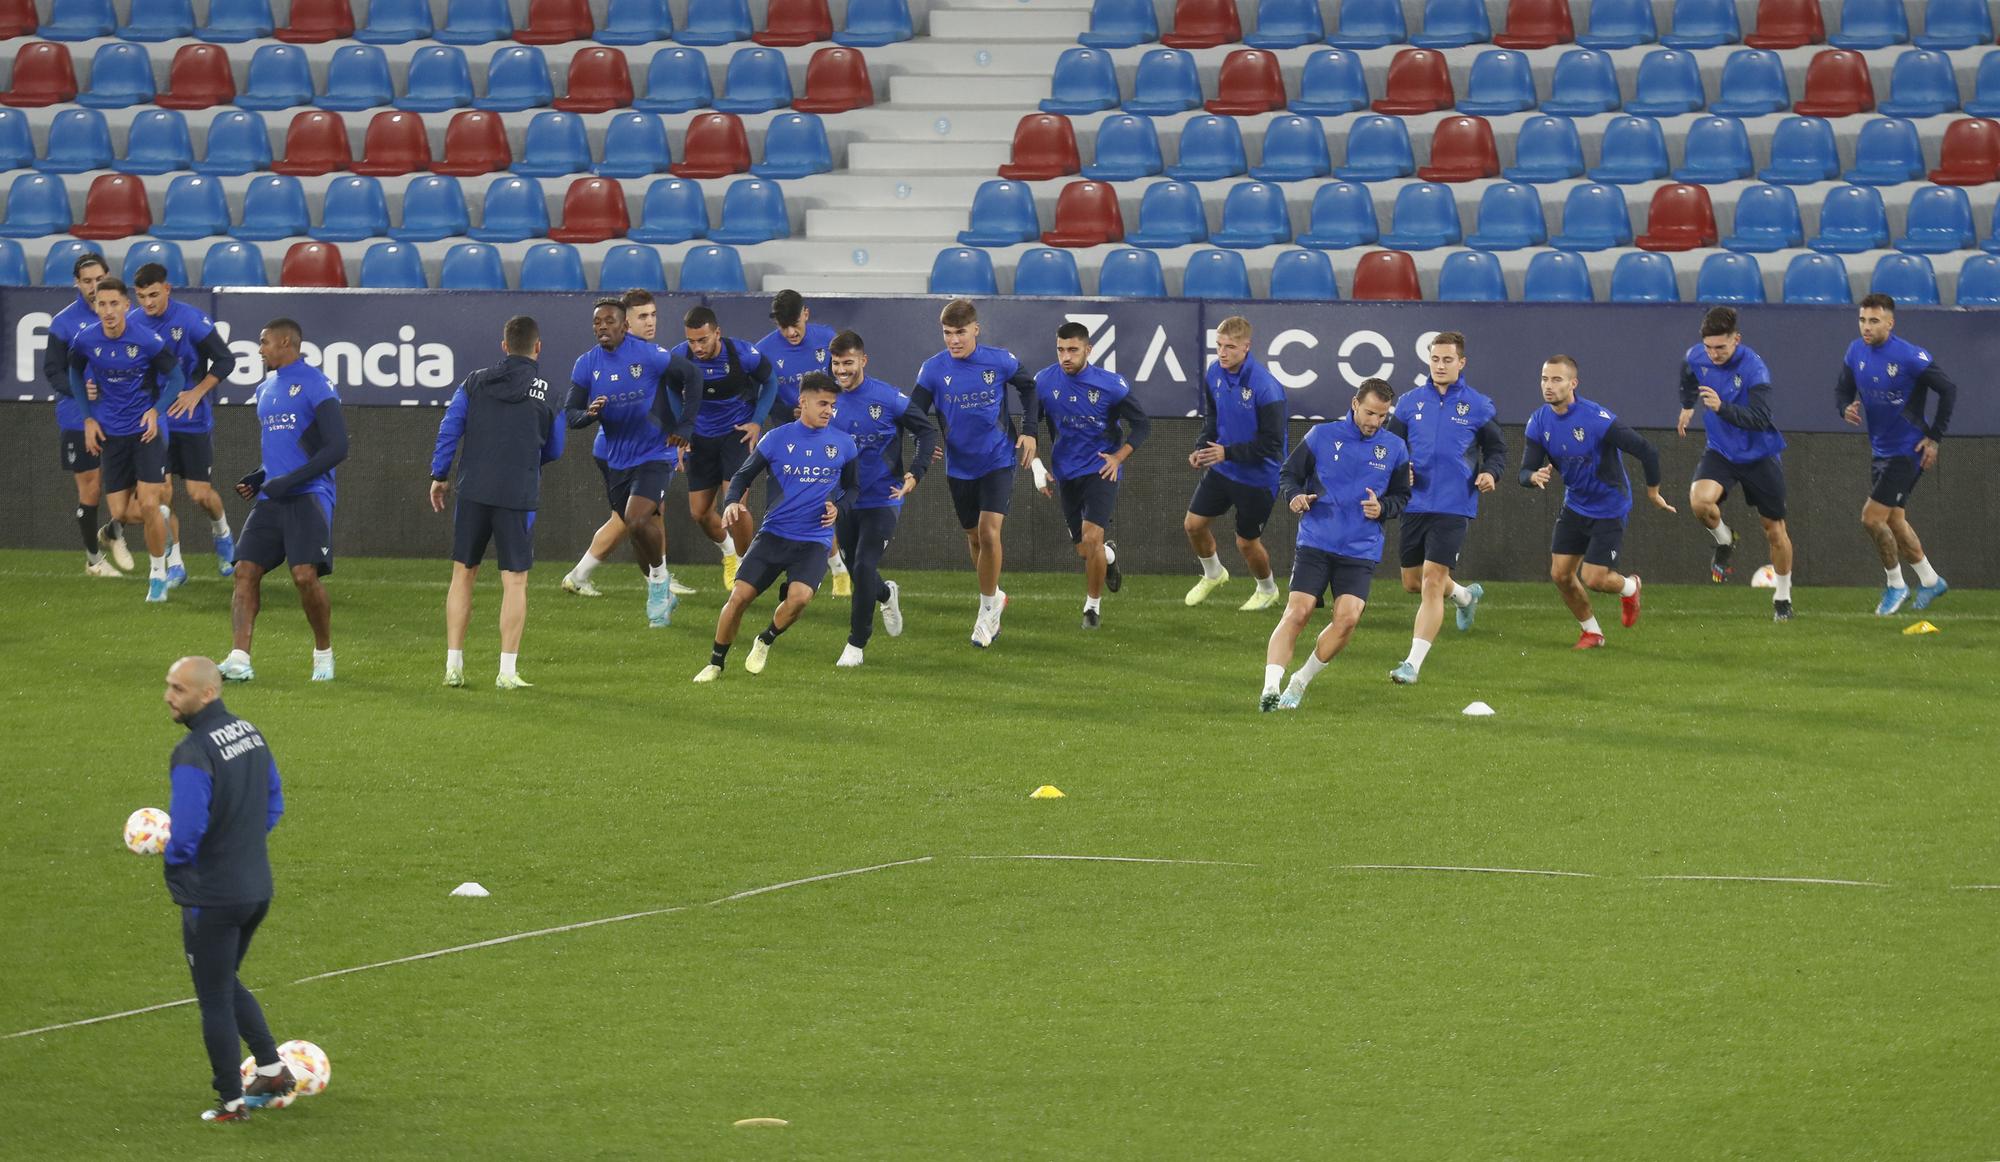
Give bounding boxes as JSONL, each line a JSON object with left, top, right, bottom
{"left": 132, "top": 262, "right": 236, "bottom": 586}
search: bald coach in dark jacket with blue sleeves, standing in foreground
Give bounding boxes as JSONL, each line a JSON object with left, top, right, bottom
{"left": 164, "top": 658, "right": 298, "bottom": 1122}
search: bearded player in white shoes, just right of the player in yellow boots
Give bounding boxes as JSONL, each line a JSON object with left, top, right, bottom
{"left": 824, "top": 330, "right": 938, "bottom": 666}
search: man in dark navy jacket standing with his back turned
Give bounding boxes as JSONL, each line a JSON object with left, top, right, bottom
{"left": 430, "top": 314, "right": 568, "bottom": 690}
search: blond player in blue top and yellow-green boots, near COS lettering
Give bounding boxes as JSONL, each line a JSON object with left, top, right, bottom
{"left": 1180, "top": 316, "right": 1290, "bottom": 610}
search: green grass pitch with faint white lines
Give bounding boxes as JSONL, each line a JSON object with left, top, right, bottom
{"left": 0, "top": 552, "right": 2000, "bottom": 1160}
